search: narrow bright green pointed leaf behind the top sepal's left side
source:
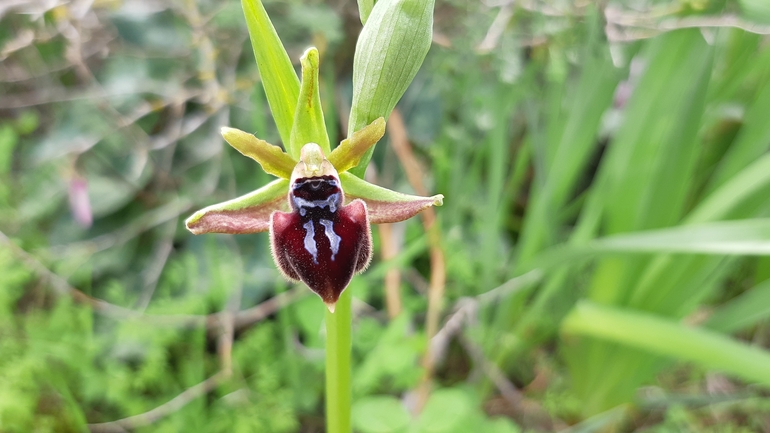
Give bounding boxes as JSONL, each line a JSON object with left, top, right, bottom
{"left": 241, "top": 0, "right": 299, "bottom": 147}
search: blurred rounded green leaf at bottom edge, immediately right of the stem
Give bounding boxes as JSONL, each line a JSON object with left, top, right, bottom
{"left": 351, "top": 395, "right": 410, "bottom": 433}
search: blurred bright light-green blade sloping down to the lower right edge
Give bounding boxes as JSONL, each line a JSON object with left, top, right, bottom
{"left": 561, "top": 301, "right": 770, "bottom": 385}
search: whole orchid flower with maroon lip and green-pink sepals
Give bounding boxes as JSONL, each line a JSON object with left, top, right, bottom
{"left": 185, "top": 48, "right": 443, "bottom": 312}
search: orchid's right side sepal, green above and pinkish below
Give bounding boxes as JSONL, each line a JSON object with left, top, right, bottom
{"left": 340, "top": 173, "right": 444, "bottom": 224}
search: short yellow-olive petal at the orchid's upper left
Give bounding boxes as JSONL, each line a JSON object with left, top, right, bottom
{"left": 222, "top": 126, "right": 297, "bottom": 179}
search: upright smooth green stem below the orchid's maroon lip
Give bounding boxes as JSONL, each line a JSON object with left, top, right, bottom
{"left": 326, "top": 289, "right": 352, "bottom": 433}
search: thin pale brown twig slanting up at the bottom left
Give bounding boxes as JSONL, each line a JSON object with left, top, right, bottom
{"left": 88, "top": 371, "right": 228, "bottom": 433}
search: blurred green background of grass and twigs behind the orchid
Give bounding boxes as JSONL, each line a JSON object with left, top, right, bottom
{"left": 0, "top": 0, "right": 770, "bottom": 433}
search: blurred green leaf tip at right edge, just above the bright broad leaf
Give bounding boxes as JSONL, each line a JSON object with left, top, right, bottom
{"left": 706, "top": 280, "right": 770, "bottom": 333}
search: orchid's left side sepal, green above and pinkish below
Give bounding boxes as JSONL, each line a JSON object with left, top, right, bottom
{"left": 185, "top": 179, "right": 289, "bottom": 235}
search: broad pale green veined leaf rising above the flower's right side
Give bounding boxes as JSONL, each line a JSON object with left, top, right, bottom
{"left": 348, "top": 0, "right": 434, "bottom": 177}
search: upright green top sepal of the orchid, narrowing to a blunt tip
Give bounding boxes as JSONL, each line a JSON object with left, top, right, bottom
{"left": 289, "top": 47, "right": 331, "bottom": 159}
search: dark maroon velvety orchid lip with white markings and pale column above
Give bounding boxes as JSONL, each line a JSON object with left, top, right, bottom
{"left": 270, "top": 143, "right": 372, "bottom": 311}
